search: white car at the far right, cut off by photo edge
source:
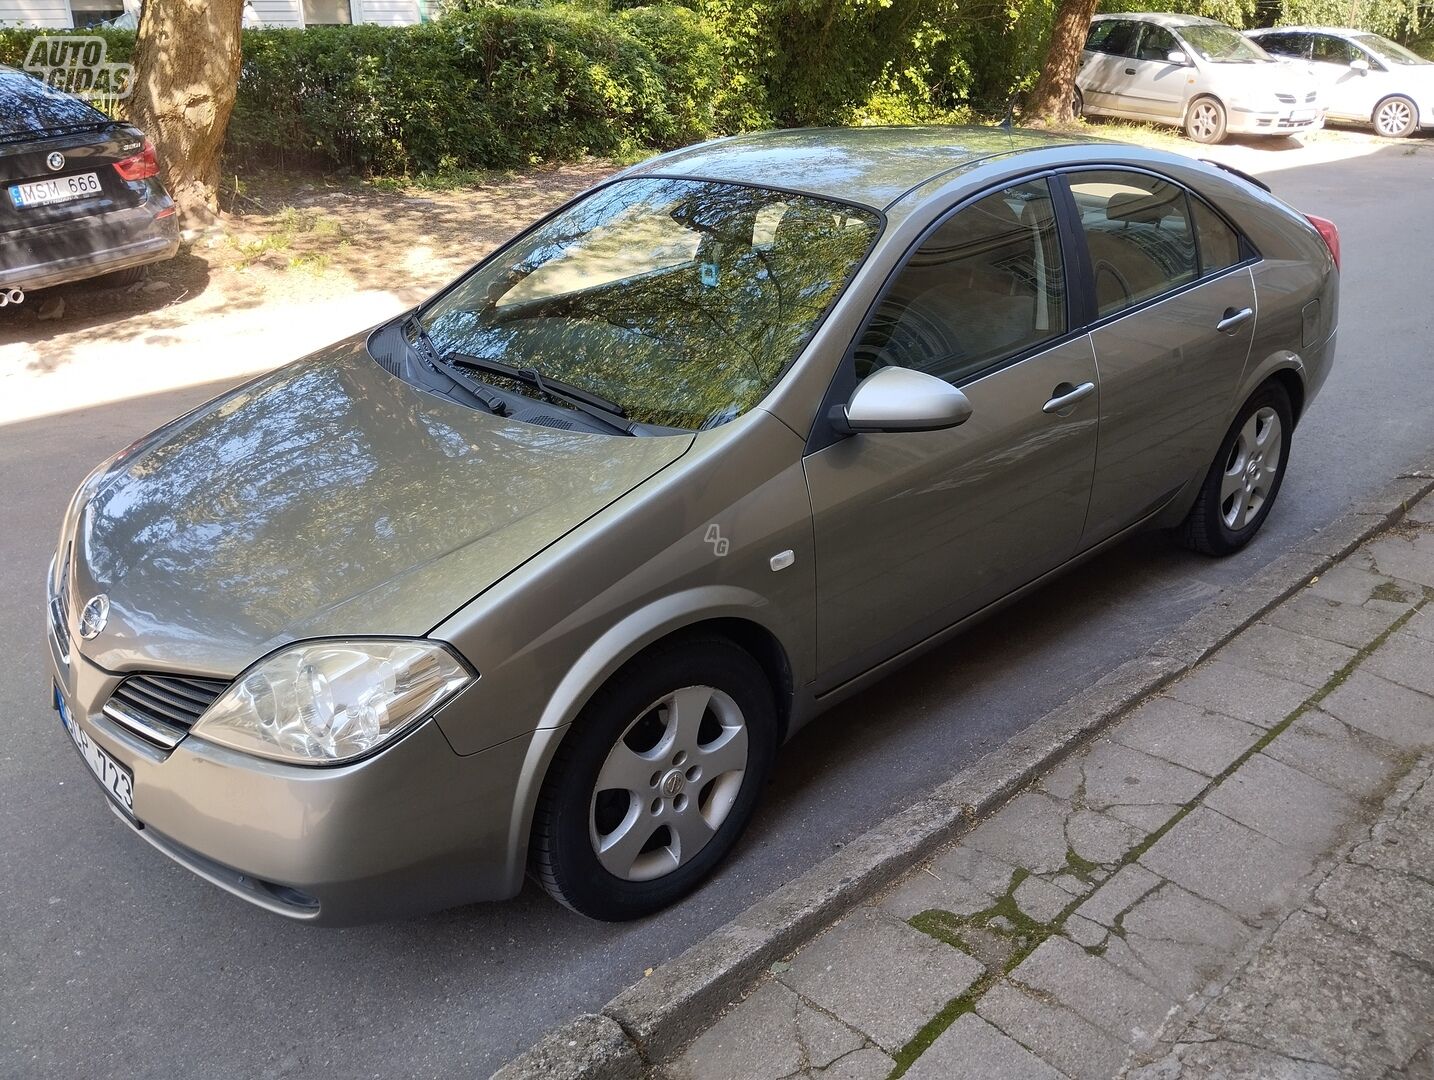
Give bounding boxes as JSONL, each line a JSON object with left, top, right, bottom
{"left": 1248, "top": 26, "right": 1434, "bottom": 139}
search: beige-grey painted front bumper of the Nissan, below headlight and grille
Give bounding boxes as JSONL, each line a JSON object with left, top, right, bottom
{"left": 49, "top": 630, "right": 531, "bottom": 925}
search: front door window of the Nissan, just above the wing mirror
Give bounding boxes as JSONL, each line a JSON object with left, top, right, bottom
{"left": 856, "top": 181, "right": 1065, "bottom": 383}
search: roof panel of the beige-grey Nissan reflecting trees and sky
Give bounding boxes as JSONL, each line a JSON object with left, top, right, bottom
{"left": 624, "top": 126, "right": 1106, "bottom": 209}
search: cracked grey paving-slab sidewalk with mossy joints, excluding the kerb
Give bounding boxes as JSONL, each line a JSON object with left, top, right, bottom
{"left": 654, "top": 496, "right": 1434, "bottom": 1080}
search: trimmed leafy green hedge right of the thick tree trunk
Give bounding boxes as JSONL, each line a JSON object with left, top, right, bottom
{"left": 0, "top": 6, "right": 761, "bottom": 175}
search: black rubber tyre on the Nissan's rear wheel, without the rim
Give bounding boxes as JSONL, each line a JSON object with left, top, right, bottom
{"left": 1176, "top": 383, "right": 1295, "bottom": 555}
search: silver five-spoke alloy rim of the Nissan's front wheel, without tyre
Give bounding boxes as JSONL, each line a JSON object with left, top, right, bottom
{"left": 588, "top": 686, "right": 749, "bottom": 881}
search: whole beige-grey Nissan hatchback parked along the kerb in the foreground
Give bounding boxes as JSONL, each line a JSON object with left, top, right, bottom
{"left": 49, "top": 129, "right": 1338, "bottom": 924}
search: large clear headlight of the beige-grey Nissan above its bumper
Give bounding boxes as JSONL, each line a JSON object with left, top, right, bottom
{"left": 192, "top": 640, "right": 472, "bottom": 764}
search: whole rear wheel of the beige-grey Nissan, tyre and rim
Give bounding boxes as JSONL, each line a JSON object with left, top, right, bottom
{"left": 1176, "top": 383, "right": 1295, "bottom": 555}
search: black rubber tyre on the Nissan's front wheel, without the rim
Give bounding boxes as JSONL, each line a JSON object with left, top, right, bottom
{"left": 529, "top": 637, "right": 777, "bottom": 922}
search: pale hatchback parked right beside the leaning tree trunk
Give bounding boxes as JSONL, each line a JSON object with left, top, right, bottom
{"left": 1076, "top": 11, "right": 1324, "bottom": 142}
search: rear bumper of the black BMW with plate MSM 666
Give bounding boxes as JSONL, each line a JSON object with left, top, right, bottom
{"left": 0, "top": 189, "right": 179, "bottom": 290}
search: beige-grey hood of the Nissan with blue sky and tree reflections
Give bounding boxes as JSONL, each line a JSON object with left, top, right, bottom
{"left": 66, "top": 338, "right": 691, "bottom": 676}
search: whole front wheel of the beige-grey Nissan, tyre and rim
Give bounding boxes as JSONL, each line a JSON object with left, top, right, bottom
{"left": 529, "top": 637, "right": 777, "bottom": 921}
